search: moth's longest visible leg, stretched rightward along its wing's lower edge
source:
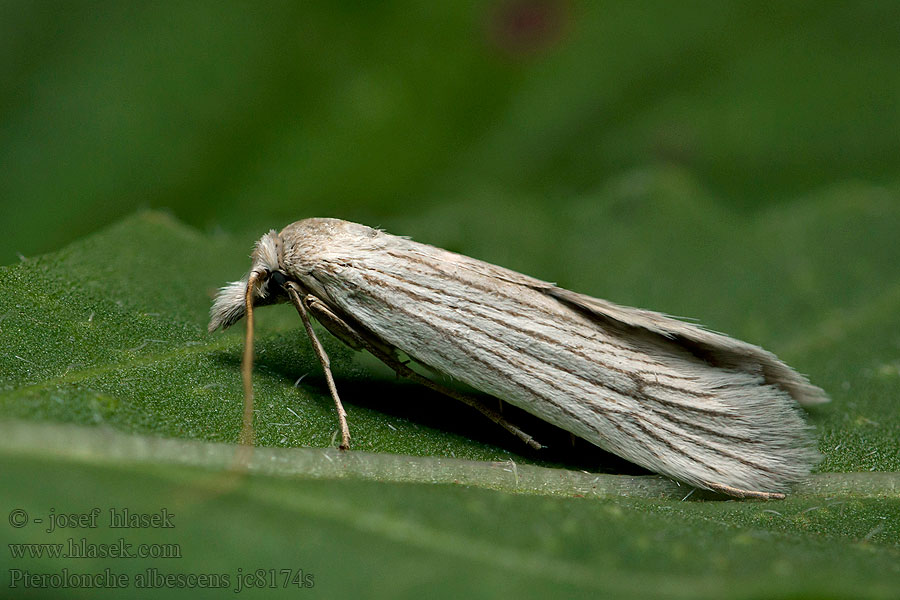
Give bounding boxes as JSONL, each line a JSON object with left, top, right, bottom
{"left": 304, "top": 295, "right": 543, "bottom": 450}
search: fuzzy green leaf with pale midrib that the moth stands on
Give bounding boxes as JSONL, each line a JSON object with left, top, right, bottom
{"left": 0, "top": 190, "right": 900, "bottom": 597}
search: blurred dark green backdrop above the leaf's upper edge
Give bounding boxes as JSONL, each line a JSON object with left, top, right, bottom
{"left": 0, "top": 0, "right": 900, "bottom": 263}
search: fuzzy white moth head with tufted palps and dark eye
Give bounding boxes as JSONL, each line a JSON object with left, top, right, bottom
{"left": 209, "top": 229, "right": 287, "bottom": 332}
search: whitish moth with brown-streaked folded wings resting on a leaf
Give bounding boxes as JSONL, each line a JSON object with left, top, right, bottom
{"left": 209, "top": 219, "right": 828, "bottom": 498}
